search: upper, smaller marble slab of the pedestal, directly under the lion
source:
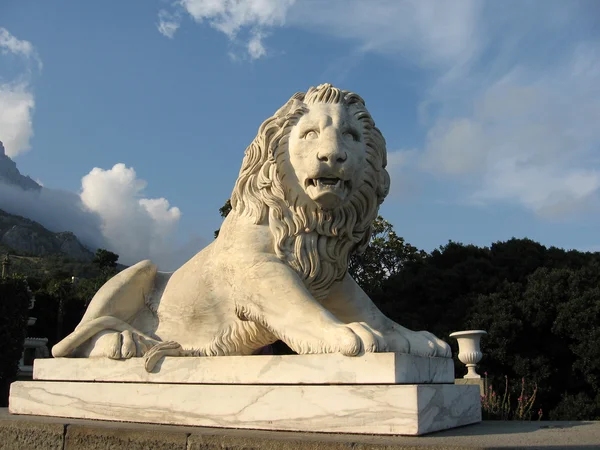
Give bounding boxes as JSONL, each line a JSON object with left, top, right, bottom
{"left": 33, "top": 353, "right": 454, "bottom": 384}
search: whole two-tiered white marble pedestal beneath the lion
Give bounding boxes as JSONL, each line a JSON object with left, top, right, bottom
{"left": 9, "top": 353, "right": 481, "bottom": 435}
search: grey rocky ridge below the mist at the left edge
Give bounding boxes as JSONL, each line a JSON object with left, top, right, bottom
{"left": 0, "top": 209, "right": 94, "bottom": 261}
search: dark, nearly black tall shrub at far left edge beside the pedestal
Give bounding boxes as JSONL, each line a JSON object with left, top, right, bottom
{"left": 0, "top": 277, "right": 30, "bottom": 406}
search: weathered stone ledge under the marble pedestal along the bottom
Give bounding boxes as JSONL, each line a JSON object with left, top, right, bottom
{"left": 0, "top": 408, "right": 600, "bottom": 450}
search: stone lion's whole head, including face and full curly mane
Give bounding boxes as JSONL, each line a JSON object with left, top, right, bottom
{"left": 231, "top": 84, "right": 390, "bottom": 298}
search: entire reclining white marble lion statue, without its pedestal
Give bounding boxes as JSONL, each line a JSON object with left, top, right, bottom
{"left": 52, "top": 84, "right": 451, "bottom": 371}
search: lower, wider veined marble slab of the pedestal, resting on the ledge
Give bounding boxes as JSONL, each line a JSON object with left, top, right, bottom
{"left": 9, "top": 381, "right": 481, "bottom": 435}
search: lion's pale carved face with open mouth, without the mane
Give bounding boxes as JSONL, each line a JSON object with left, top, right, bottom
{"left": 280, "top": 104, "right": 367, "bottom": 210}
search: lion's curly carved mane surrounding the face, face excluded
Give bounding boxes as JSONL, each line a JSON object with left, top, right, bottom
{"left": 231, "top": 84, "right": 390, "bottom": 299}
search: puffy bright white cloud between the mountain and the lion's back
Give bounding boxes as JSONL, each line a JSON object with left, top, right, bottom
{"left": 81, "top": 164, "right": 181, "bottom": 264}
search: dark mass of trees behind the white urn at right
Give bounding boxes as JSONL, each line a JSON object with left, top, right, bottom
{"left": 373, "top": 239, "right": 600, "bottom": 420}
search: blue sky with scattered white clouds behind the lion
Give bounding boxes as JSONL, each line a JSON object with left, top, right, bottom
{"left": 0, "top": 0, "right": 600, "bottom": 268}
